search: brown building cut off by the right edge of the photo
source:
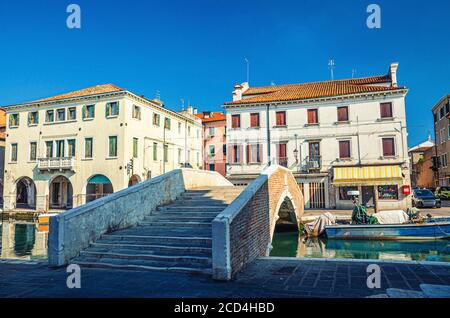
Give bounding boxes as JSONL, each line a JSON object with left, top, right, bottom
{"left": 432, "top": 94, "right": 450, "bottom": 186}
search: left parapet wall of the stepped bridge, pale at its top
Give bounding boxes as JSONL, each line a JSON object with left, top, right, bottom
{"left": 48, "top": 169, "right": 232, "bottom": 266}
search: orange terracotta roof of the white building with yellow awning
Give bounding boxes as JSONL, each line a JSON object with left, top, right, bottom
{"left": 225, "top": 75, "right": 405, "bottom": 105}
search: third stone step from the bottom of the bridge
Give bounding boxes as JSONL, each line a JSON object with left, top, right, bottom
{"left": 89, "top": 241, "right": 212, "bottom": 257}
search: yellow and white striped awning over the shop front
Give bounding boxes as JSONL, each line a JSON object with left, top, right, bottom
{"left": 333, "top": 165, "right": 403, "bottom": 186}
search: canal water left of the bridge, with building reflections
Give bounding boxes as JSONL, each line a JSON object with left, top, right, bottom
{"left": 0, "top": 218, "right": 48, "bottom": 260}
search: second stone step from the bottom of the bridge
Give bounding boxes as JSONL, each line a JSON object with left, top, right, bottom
{"left": 80, "top": 249, "right": 211, "bottom": 267}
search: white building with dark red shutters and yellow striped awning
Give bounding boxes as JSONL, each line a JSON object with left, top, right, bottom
{"left": 224, "top": 64, "right": 411, "bottom": 210}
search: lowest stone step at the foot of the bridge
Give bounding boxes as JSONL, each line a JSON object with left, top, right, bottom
{"left": 76, "top": 259, "right": 212, "bottom": 275}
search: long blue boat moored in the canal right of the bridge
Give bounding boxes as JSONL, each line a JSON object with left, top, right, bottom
{"left": 325, "top": 218, "right": 450, "bottom": 240}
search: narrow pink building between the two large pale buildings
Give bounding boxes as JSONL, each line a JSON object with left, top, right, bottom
{"left": 196, "top": 111, "right": 227, "bottom": 176}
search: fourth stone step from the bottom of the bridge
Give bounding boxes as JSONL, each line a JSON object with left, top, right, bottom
{"left": 101, "top": 234, "right": 212, "bottom": 248}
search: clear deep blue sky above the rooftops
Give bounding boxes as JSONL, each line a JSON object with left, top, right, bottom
{"left": 0, "top": 0, "right": 450, "bottom": 146}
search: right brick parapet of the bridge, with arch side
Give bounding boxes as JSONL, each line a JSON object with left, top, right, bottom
{"left": 212, "top": 165, "right": 303, "bottom": 280}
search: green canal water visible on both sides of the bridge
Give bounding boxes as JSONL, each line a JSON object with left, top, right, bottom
{"left": 0, "top": 218, "right": 450, "bottom": 262}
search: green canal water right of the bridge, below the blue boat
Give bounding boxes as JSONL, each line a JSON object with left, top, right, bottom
{"left": 270, "top": 231, "right": 450, "bottom": 262}
